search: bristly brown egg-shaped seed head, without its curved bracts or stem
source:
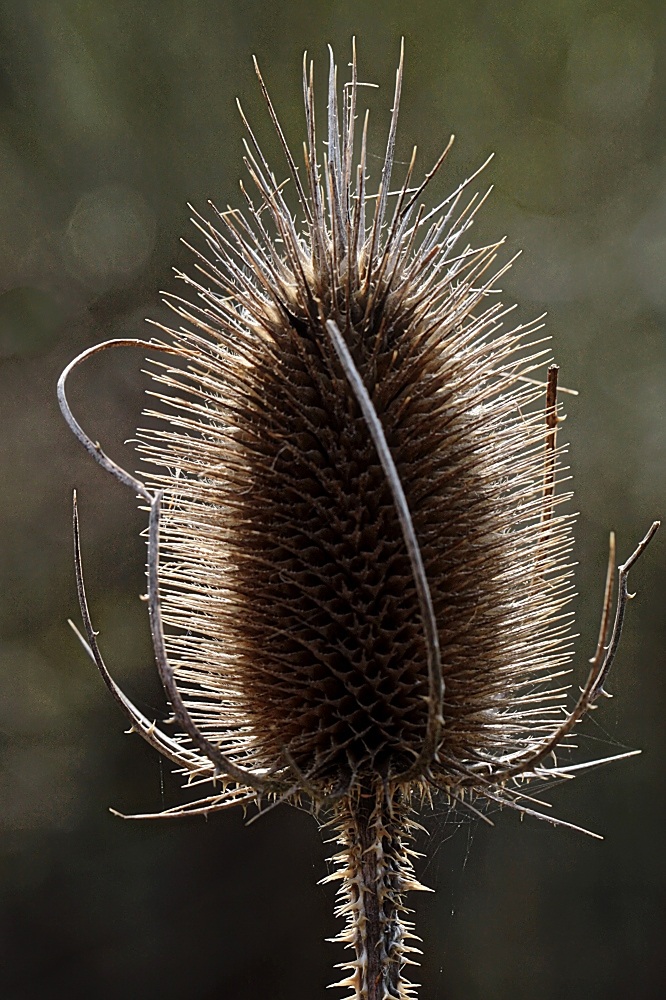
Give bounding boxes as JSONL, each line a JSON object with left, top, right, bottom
{"left": 137, "top": 45, "right": 571, "bottom": 797}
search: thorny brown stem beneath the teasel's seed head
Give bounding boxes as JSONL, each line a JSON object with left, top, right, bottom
{"left": 330, "top": 778, "right": 424, "bottom": 1000}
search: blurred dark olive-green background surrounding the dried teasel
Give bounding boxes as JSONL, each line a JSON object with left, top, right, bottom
{"left": 0, "top": 0, "right": 666, "bottom": 1000}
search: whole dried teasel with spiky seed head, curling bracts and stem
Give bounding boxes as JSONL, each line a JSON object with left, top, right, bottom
{"left": 60, "top": 41, "right": 657, "bottom": 1000}
